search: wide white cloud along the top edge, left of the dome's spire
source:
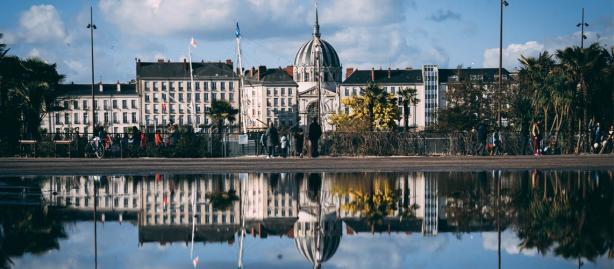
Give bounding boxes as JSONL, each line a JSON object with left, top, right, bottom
{"left": 99, "top": 0, "right": 307, "bottom": 40}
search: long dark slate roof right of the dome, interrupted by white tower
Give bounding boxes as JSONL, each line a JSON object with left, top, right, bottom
{"left": 341, "top": 68, "right": 510, "bottom": 85}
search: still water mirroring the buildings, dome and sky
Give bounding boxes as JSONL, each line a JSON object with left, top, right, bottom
{"left": 0, "top": 171, "right": 614, "bottom": 268}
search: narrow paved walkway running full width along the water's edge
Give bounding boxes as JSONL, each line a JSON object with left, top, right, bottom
{"left": 0, "top": 155, "right": 614, "bottom": 176}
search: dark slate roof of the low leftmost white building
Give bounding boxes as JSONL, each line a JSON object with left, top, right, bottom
{"left": 58, "top": 83, "right": 137, "bottom": 96}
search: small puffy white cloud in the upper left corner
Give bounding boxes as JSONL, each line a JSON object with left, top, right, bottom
{"left": 14, "top": 5, "right": 70, "bottom": 43}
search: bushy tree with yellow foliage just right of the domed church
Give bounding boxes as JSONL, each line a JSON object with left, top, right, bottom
{"left": 331, "top": 83, "right": 400, "bottom": 131}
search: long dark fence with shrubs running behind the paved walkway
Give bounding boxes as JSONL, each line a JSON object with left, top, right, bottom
{"left": 18, "top": 131, "right": 612, "bottom": 157}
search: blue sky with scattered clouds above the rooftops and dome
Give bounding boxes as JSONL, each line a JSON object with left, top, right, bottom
{"left": 0, "top": 0, "right": 614, "bottom": 83}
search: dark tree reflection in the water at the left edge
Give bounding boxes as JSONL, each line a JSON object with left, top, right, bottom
{"left": 0, "top": 206, "right": 67, "bottom": 268}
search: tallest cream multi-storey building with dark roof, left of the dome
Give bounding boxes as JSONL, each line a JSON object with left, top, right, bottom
{"left": 136, "top": 60, "right": 239, "bottom": 130}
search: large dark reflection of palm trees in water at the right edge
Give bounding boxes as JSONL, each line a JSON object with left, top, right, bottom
{"left": 514, "top": 172, "right": 614, "bottom": 261}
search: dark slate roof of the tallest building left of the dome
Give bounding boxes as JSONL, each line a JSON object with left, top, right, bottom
{"left": 136, "top": 62, "right": 238, "bottom": 79}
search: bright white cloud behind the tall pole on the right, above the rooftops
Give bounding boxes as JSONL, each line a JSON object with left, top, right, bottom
{"left": 482, "top": 41, "right": 545, "bottom": 68}
